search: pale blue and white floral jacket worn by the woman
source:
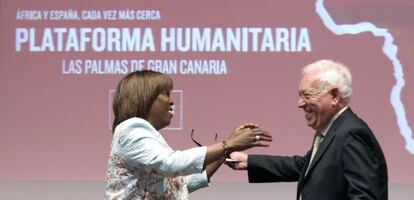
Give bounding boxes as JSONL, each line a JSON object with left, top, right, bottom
{"left": 105, "top": 118, "right": 208, "bottom": 200}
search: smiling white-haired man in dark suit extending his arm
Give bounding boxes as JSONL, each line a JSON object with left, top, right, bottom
{"left": 229, "top": 60, "right": 388, "bottom": 200}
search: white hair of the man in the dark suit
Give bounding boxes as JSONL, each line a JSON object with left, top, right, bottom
{"left": 302, "top": 60, "right": 352, "bottom": 103}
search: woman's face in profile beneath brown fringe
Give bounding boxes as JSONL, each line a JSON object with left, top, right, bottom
{"left": 148, "top": 91, "right": 174, "bottom": 130}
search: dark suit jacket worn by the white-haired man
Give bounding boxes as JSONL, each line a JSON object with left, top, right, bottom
{"left": 248, "top": 108, "right": 388, "bottom": 200}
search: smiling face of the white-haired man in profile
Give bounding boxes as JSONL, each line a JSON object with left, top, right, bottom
{"left": 298, "top": 73, "right": 337, "bottom": 131}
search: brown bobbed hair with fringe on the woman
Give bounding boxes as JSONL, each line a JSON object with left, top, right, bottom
{"left": 112, "top": 70, "right": 173, "bottom": 132}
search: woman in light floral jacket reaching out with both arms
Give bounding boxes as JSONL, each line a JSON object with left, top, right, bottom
{"left": 105, "top": 71, "right": 271, "bottom": 199}
